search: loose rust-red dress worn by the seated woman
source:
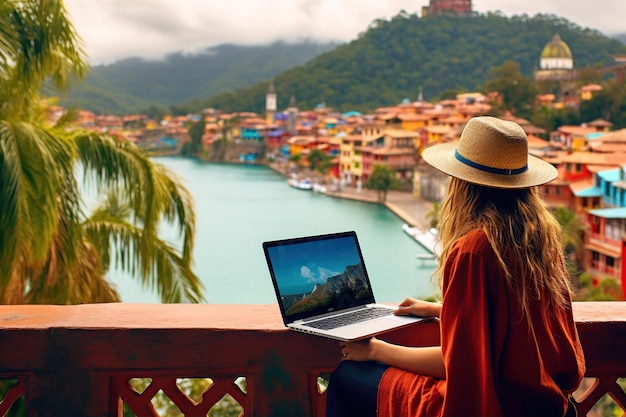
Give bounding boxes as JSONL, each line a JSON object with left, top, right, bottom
{"left": 378, "top": 231, "right": 585, "bottom": 417}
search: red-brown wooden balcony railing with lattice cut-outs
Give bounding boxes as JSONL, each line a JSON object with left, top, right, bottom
{"left": 0, "top": 302, "right": 626, "bottom": 417}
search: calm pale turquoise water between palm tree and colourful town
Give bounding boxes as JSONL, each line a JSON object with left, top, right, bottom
{"left": 109, "top": 157, "right": 433, "bottom": 304}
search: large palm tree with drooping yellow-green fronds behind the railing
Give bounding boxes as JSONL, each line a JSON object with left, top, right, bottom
{"left": 0, "top": 0, "right": 203, "bottom": 304}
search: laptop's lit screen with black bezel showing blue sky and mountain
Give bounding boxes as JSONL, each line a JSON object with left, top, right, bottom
{"left": 263, "top": 232, "right": 374, "bottom": 324}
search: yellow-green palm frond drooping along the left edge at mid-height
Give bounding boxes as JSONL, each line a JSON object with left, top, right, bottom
{"left": 0, "top": 120, "right": 72, "bottom": 285}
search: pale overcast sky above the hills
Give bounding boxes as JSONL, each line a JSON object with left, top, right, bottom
{"left": 65, "top": 0, "right": 626, "bottom": 65}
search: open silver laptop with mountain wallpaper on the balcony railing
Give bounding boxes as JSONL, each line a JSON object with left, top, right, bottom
{"left": 263, "top": 231, "right": 424, "bottom": 341}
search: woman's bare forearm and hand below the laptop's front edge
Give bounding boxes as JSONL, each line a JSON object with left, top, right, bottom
{"left": 340, "top": 337, "right": 446, "bottom": 379}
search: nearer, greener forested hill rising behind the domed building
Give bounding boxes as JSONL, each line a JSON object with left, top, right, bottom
{"left": 201, "top": 13, "right": 626, "bottom": 112}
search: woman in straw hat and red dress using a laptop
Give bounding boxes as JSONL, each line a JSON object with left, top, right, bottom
{"left": 327, "top": 117, "right": 585, "bottom": 417}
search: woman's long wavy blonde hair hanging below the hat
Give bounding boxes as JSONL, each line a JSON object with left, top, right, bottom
{"left": 435, "top": 177, "right": 571, "bottom": 316}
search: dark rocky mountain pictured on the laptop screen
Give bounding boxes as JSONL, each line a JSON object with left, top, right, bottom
{"left": 285, "top": 263, "right": 371, "bottom": 316}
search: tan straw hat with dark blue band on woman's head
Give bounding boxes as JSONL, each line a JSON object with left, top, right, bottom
{"left": 422, "top": 116, "right": 558, "bottom": 188}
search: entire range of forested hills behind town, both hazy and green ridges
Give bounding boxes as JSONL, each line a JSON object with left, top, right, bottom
{"left": 56, "top": 12, "right": 626, "bottom": 117}
